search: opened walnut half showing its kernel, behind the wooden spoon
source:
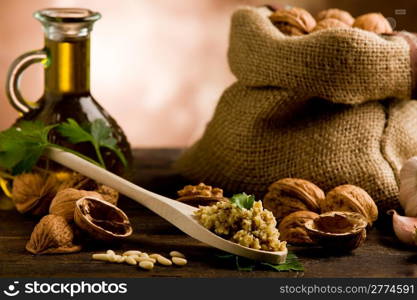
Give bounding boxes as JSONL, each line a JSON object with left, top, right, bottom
{"left": 177, "top": 183, "right": 227, "bottom": 207}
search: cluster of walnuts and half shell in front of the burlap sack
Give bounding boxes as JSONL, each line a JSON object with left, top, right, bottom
{"left": 263, "top": 178, "right": 378, "bottom": 250}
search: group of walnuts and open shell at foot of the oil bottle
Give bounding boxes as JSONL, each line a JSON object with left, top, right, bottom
{"left": 12, "top": 171, "right": 132, "bottom": 254}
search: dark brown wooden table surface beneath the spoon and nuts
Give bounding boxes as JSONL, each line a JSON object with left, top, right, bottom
{"left": 0, "top": 149, "right": 417, "bottom": 277}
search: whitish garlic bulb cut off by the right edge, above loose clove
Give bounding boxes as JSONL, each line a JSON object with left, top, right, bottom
{"left": 399, "top": 156, "right": 417, "bottom": 217}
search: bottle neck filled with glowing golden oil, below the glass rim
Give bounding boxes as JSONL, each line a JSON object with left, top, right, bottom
{"left": 45, "top": 38, "right": 90, "bottom": 94}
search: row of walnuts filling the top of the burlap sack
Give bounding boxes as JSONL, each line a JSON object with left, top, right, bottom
{"left": 269, "top": 7, "right": 392, "bottom": 36}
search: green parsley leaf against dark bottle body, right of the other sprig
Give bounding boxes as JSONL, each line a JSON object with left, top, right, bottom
{"left": 57, "top": 119, "right": 127, "bottom": 168}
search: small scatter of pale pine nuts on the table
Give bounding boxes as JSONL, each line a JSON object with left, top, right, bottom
{"left": 92, "top": 250, "right": 187, "bottom": 270}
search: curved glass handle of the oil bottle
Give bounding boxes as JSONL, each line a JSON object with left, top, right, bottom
{"left": 6, "top": 50, "right": 48, "bottom": 114}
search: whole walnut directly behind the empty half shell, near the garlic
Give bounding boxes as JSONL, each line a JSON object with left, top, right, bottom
{"left": 319, "top": 184, "right": 378, "bottom": 226}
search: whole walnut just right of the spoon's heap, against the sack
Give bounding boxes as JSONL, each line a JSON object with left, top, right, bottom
{"left": 263, "top": 178, "right": 324, "bottom": 220}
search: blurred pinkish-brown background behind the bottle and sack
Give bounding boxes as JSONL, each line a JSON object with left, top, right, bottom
{"left": 0, "top": 0, "right": 417, "bottom": 147}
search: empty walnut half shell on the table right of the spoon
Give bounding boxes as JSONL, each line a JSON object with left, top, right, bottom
{"left": 304, "top": 211, "right": 367, "bottom": 252}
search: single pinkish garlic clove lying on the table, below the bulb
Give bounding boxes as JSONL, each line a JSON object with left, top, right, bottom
{"left": 387, "top": 209, "right": 417, "bottom": 246}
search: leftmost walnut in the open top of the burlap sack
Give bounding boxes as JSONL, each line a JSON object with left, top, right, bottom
{"left": 269, "top": 7, "right": 316, "bottom": 36}
